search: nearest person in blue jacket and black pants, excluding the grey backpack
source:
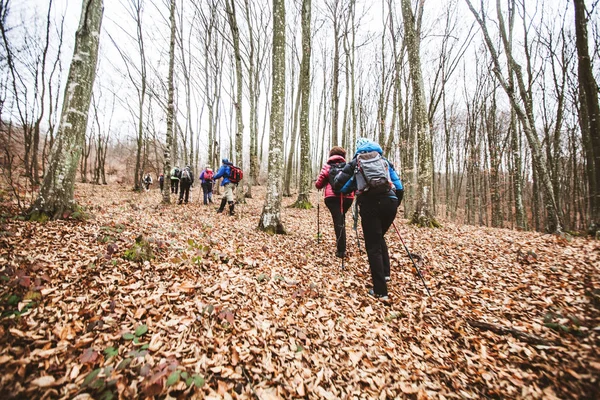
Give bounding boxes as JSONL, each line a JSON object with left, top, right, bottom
{"left": 335, "top": 138, "right": 404, "bottom": 300}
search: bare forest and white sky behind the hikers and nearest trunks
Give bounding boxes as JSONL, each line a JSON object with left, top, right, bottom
{"left": 1, "top": 0, "right": 600, "bottom": 231}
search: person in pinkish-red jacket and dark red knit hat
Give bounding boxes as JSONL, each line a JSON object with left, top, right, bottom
{"left": 315, "top": 146, "right": 354, "bottom": 258}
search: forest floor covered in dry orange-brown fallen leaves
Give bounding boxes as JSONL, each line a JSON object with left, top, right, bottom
{"left": 0, "top": 185, "right": 600, "bottom": 399}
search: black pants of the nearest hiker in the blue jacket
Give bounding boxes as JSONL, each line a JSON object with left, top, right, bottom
{"left": 358, "top": 195, "right": 398, "bottom": 296}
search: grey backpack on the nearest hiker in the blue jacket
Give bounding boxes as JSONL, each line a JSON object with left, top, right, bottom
{"left": 354, "top": 151, "right": 392, "bottom": 194}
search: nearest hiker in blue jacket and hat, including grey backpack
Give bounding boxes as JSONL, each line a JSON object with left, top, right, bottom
{"left": 334, "top": 138, "right": 404, "bottom": 300}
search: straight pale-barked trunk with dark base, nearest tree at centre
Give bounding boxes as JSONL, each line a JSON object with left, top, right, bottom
{"left": 258, "top": 0, "right": 285, "bottom": 234}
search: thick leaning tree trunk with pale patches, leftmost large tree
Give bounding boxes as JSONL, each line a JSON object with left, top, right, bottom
{"left": 29, "top": 0, "right": 104, "bottom": 220}
